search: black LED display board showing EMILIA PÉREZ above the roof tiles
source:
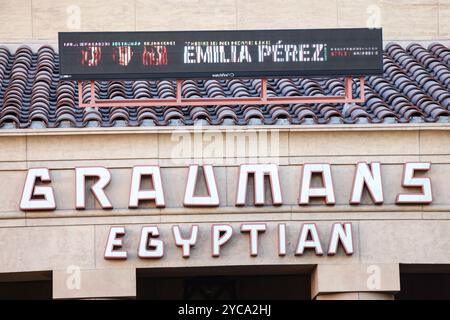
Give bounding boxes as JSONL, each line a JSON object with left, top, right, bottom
{"left": 59, "top": 29, "right": 383, "bottom": 80}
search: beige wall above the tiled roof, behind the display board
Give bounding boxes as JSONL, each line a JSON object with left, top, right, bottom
{"left": 0, "top": 0, "right": 450, "bottom": 44}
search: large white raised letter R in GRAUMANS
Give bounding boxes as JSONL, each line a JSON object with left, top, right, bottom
{"left": 75, "top": 167, "right": 112, "bottom": 209}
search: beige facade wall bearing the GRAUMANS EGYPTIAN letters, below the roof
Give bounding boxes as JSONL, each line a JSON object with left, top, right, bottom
{"left": 0, "top": 124, "right": 450, "bottom": 298}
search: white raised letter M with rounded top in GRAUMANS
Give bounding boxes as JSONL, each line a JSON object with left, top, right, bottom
{"left": 236, "top": 164, "right": 283, "bottom": 206}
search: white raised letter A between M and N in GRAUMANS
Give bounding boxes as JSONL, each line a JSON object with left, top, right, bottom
{"left": 299, "top": 163, "right": 336, "bottom": 205}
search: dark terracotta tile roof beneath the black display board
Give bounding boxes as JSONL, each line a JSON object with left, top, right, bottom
{"left": 0, "top": 43, "right": 450, "bottom": 128}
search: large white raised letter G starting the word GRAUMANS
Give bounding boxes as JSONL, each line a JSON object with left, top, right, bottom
{"left": 20, "top": 168, "right": 56, "bottom": 211}
